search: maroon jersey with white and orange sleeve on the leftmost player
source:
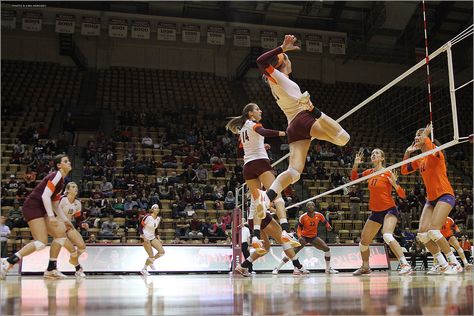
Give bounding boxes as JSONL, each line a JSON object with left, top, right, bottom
{"left": 22, "top": 171, "right": 64, "bottom": 221}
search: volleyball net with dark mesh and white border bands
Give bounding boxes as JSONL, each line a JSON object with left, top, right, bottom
{"left": 236, "top": 25, "right": 473, "bottom": 216}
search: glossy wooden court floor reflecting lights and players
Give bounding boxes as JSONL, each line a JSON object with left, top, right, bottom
{"left": 0, "top": 272, "right": 473, "bottom": 315}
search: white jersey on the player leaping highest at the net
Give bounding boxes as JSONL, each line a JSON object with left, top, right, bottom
{"left": 269, "top": 69, "right": 305, "bottom": 124}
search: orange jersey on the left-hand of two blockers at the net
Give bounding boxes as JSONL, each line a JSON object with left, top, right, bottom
{"left": 351, "top": 169, "right": 406, "bottom": 212}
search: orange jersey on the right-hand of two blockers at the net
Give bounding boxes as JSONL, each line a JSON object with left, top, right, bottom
{"left": 402, "top": 137, "right": 454, "bottom": 201}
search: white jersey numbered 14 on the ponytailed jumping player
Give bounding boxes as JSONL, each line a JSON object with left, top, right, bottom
{"left": 240, "top": 120, "right": 268, "bottom": 164}
